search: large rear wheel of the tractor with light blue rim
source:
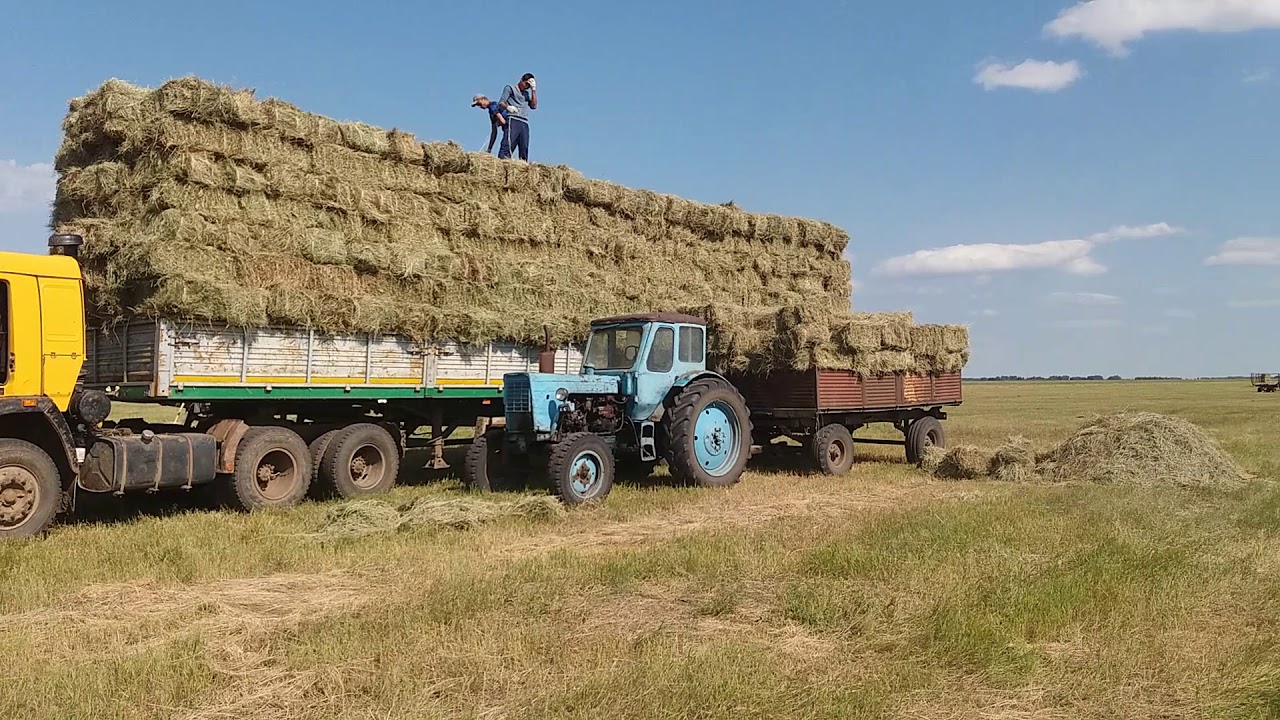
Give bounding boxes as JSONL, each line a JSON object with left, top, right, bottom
{"left": 666, "top": 378, "right": 753, "bottom": 488}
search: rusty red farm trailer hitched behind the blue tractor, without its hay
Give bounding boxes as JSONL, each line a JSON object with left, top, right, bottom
{"left": 730, "top": 369, "right": 964, "bottom": 475}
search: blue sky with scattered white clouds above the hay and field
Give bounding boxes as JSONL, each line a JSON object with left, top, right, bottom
{"left": 0, "top": 0, "right": 1280, "bottom": 375}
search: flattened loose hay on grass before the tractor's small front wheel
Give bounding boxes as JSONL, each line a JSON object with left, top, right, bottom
{"left": 314, "top": 496, "right": 564, "bottom": 539}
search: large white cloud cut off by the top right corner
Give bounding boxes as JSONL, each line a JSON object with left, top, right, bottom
{"left": 1044, "top": 0, "right": 1280, "bottom": 55}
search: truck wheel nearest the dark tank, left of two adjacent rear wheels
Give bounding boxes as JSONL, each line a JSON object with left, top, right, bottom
{"left": 232, "top": 427, "right": 312, "bottom": 511}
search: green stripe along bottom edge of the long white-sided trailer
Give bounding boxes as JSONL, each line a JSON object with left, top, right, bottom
{"left": 118, "top": 386, "right": 502, "bottom": 402}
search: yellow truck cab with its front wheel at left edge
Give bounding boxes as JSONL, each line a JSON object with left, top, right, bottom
{"left": 0, "top": 236, "right": 98, "bottom": 538}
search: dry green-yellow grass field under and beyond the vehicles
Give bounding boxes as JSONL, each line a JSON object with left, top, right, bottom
{"left": 0, "top": 382, "right": 1280, "bottom": 720}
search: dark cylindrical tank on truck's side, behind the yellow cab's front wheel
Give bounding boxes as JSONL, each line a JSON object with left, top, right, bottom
{"left": 78, "top": 433, "right": 218, "bottom": 495}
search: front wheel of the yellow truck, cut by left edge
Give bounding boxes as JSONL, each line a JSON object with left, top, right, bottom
{"left": 0, "top": 439, "right": 63, "bottom": 539}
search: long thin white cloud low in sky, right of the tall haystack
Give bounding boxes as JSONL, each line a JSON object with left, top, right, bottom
{"left": 872, "top": 223, "right": 1181, "bottom": 277}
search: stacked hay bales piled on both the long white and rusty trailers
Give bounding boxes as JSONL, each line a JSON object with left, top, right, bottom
{"left": 52, "top": 77, "right": 968, "bottom": 372}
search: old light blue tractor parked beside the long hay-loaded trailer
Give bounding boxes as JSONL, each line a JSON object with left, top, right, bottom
{"left": 463, "top": 313, "right": 753, "bottom": 505}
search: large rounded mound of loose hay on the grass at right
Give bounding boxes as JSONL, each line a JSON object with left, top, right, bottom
{"left": 1037, "top": 413, "right": 1249, "bottom": 489}
